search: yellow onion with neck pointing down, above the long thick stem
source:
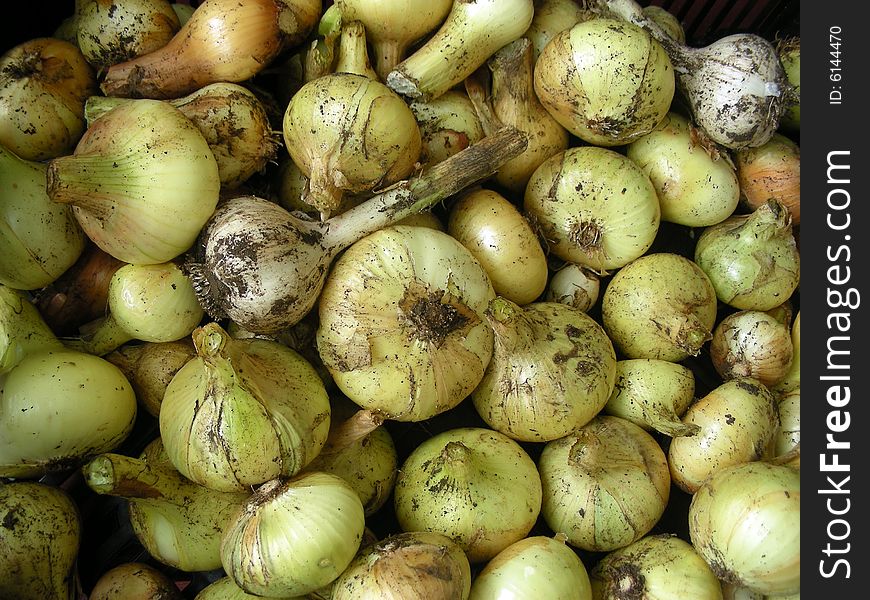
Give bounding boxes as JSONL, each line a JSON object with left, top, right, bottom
{"left": 283, "top": 73, "right": 422, "bottom": 217}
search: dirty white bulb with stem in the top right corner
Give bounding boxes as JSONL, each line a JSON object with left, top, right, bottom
{"left": 603, "top": 0, "right": 789, "bottom": 149}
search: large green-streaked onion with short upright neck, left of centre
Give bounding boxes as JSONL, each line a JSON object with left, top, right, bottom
{"left": 160, "top": 322, "right": 330, "bottom": 491}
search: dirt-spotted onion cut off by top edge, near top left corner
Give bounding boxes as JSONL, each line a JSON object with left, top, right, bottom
{"left": 75, "top": 0, "right": 181, "bottom": 69}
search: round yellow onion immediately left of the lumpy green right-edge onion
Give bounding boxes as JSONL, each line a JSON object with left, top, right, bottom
{"left": 601, "top": 252, "right": 717, "bottom": 362}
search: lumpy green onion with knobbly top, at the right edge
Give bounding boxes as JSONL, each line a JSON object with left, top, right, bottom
{"left": 695, "top": 200, "right": 800, "bottom": 311}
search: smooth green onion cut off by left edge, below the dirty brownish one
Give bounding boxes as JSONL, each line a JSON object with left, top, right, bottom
{"left": 0, "top": 144, "right": 86, "bottom": 290}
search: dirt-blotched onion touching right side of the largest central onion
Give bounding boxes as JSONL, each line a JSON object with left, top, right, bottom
{"left": 471, "top": 297, "right": 616, "bottom": 442}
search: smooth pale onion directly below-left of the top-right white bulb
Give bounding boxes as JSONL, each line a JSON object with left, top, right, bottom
{"left": 626, "top": 112, "right": 742, "bottom": 227}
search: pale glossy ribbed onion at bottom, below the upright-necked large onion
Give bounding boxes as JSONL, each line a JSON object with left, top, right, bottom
{"left": 221, "top": 472, "right": 365, "bottom": 598}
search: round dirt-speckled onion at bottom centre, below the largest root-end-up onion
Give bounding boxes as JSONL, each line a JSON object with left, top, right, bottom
{"left": 393, "top": 427, "right": 541, "bottom": 563}
